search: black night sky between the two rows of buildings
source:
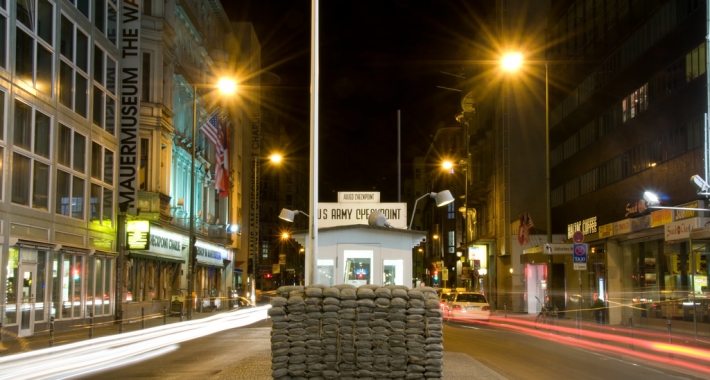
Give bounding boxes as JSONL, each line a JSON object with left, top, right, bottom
{"left": 222, "top": 0, "right": 492, "bottom": 202}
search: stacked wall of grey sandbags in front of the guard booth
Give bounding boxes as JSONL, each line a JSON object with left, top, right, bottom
{"left": 268, "top": 284, "right": 444, "bottom": 380}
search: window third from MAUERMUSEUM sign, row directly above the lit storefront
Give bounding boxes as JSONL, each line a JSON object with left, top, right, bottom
{"left": 12, "top": 100, "right": 51, "bottom": 210}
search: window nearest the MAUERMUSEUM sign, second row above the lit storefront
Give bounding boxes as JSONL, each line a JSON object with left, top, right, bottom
{"left": 92, "top": 46, "right": 116, "bottom": 135}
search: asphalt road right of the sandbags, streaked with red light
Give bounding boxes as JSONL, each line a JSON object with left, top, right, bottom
{"left": 444, "top": 321, "right": 707, "bottom": 380}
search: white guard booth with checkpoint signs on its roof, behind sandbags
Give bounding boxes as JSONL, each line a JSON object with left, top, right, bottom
{"left": 293, "top": 192, "right": 426, "bottom": 287}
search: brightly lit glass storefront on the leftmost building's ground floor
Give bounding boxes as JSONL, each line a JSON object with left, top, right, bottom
{"left": 2, "top": 238, "right": 115, "bottom": 337}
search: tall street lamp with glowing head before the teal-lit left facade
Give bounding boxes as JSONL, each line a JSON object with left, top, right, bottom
{"left": 187, "top": 78, "right": 237, "bottom": 321}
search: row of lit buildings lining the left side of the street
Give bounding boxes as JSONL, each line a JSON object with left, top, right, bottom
{"left": 0, "top": 0, "right": 253, "bottom": 336}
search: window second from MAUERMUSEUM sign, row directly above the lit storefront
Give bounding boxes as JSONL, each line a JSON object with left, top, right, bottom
{"left": 54, "top": 124, "right": 86, "bottom": 219}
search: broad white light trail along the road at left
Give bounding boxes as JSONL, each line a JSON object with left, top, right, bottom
{"left": 0, "top": 306, "right": 271, "bottom": 380}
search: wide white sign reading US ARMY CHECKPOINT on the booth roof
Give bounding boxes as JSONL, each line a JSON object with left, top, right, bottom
{"left": 318, "top": 202, "right": 407, "bottom": 228}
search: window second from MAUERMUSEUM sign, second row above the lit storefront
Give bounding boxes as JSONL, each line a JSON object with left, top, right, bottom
{"left": 59, "top": 15, "right": 89, "bottom": 118}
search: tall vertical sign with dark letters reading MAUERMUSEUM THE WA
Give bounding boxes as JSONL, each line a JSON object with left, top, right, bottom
{"left": 118, "top": 0, "right": 141, "bottom": 215}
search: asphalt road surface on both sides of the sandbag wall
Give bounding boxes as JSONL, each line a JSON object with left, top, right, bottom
{"left": 68, "top": 319, "right": 707, "bottom": 380}
